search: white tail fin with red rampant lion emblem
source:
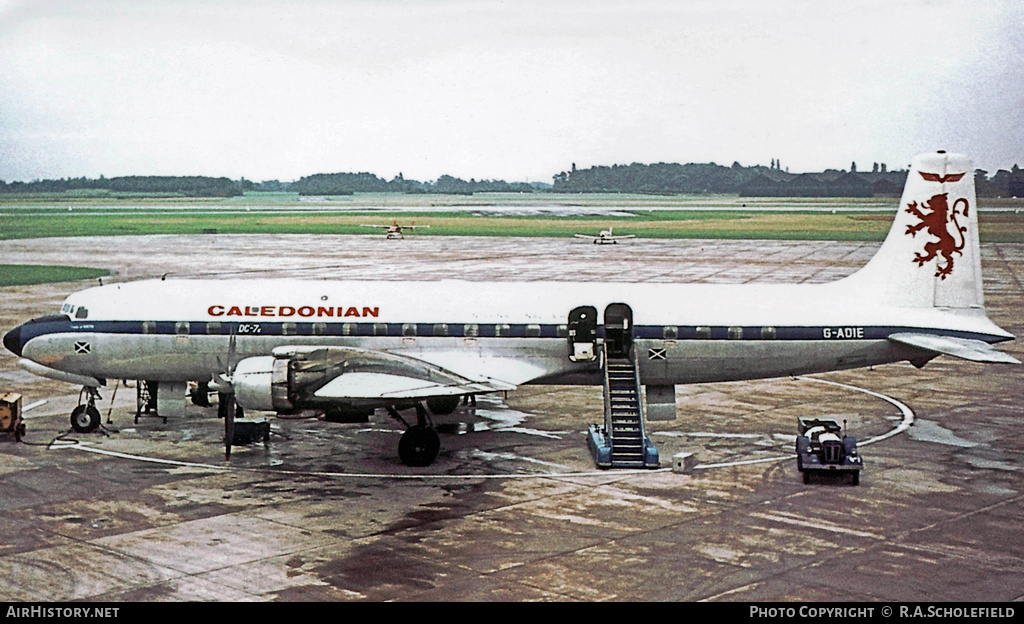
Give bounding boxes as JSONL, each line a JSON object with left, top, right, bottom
{"left": 848, "top": 152, "right": 984, "bottom": 309}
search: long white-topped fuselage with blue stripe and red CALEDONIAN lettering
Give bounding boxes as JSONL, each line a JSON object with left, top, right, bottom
{"left": 24, "top": 280, "right": 1009, "bottom": 385}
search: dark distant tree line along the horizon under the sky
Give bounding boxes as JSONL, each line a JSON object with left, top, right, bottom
{"left": 0, "top": 159, "right": 1024, "bottom": 198}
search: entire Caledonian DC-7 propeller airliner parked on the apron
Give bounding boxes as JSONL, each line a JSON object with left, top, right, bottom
{"left": 4, "top": 152, "right": 1019, "bottom": 465}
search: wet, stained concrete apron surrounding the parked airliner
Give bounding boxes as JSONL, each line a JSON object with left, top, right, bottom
{"left": 0, "top": 235, "right": 1024, "bottom": 602}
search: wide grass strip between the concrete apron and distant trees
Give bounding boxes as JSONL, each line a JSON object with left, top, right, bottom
{"left": 0, "top": 193, "right": 1024, "bottom": 243}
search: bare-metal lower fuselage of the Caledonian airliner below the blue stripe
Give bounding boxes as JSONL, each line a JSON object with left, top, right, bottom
{"left": 24, "top": 328, "right": 937, "bottom": 385}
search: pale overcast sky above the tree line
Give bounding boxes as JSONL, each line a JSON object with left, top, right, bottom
{"left": 0, "top": 0, "right": 1024, "bottom": 182}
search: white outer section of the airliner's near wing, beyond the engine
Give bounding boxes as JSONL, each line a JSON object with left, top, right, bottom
{"left": 315, "top": 372, "right": 505, "bottom": 400}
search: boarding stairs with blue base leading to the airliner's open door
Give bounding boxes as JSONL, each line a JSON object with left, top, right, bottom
{"left": 588, "top": 344, "right": 658, "bottom": 468}
